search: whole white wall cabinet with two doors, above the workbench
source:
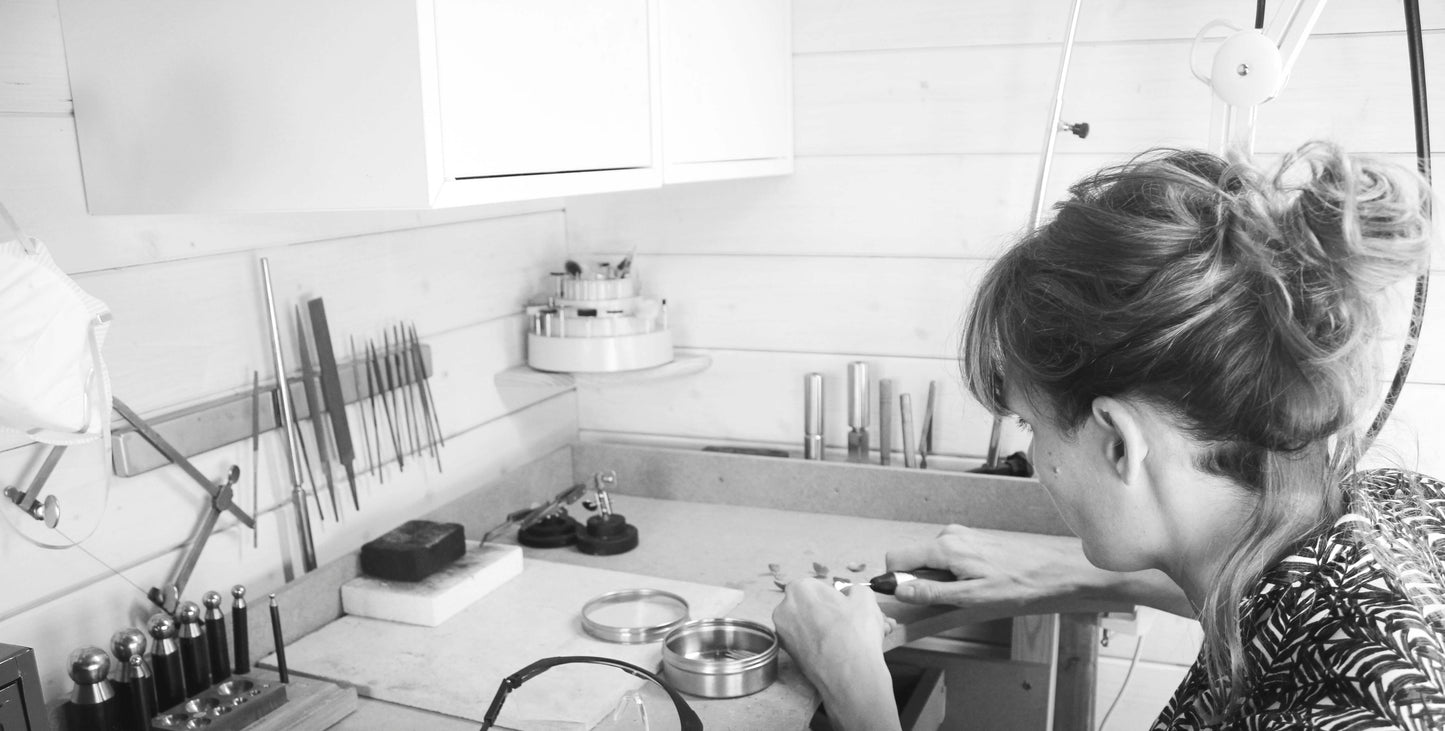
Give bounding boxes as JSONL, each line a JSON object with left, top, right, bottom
{"left": 61, "top": 0, "right": 792, "bottom": 214}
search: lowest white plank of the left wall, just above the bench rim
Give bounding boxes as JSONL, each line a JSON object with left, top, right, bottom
{"left": 0, "top": 393, "right": 577, "bottom": 698}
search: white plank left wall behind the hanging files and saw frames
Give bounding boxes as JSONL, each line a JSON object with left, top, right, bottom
{"left": 0, "top": 0, "right": 577, "bottom": 699}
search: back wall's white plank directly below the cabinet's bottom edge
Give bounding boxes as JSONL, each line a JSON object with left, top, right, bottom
{"left": 568, "top": 155, "right": 1103, "bottom": 258}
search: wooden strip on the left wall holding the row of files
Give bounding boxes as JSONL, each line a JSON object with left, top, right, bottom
{"left": 110, "top": 344, "right": 435, "bottom": 477}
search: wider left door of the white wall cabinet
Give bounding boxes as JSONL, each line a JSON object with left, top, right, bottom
{"left": 436, "top": 0, "right": 653, "bottom": 179}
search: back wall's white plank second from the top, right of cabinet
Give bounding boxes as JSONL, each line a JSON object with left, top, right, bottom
{"left": 793, "top": 32, "right": 1445, "bottom": 155}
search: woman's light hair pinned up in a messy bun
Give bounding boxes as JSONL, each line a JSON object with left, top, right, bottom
{"left": 961, "top": 142, "right": 1431, "bottom": 714}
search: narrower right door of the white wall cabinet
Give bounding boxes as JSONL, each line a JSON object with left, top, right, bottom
{"left": 660, "top": 0, "right": 793, "bottom": 166}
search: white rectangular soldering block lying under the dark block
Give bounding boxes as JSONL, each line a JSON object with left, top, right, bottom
{"left": 341, "top": 540, "right": 522, "bottom": 627}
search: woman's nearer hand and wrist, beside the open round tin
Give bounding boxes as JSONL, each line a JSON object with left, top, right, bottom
{"left": 773, "top": 578, "right": 899, "bottom": 730}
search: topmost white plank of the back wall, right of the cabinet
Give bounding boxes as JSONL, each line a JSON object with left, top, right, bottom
{"left": 793, "top": 0, "right": 1445, "bottom": 53}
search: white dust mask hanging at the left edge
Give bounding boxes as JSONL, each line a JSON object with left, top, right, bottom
{"left": 0, "top": 208, "right": 110, "bottom": 445}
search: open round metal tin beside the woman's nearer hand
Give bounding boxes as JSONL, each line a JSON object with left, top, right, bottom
{"left": 662, "top": 618, "right": 777, "bottom": 698}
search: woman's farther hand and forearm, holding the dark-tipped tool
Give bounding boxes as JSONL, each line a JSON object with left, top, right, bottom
{"left": 887, "top": 526, "right": 1191, "bottom": 620}
